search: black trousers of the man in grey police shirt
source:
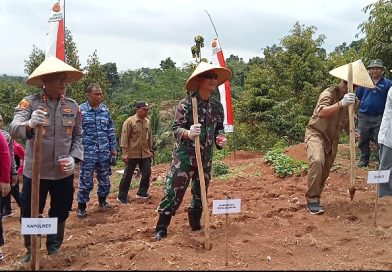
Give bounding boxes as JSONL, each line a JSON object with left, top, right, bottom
{"left": 21, "top": 175, "right": 74, "bottom": 224}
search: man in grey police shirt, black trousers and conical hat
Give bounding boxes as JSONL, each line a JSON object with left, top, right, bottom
{"left": 9, "top": 57, "right": 83, "bottom": 262}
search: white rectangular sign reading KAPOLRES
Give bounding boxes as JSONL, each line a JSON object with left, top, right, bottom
{"left": 21, "top": 217, "right": 57, "bottom": 235}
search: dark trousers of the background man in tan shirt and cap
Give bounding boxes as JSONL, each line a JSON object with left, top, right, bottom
{"left": 118, "top": 158, "right": 151, "bottom": 199}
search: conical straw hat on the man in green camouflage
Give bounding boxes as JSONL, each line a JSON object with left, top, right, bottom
{"left": 185, "top": 61, "right": 231, "bottom": 92}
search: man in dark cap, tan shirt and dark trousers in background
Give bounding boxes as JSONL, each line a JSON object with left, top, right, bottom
{"left": 117, "top": 101, "right": 153, "bottom": 205}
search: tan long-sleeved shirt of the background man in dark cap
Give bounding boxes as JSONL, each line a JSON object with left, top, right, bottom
{"left": 121, "top": 114, "right": 152, "bottom": 159}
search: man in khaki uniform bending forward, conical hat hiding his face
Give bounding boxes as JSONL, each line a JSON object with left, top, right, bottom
{"left": 305, "top": 60, "right": 374, "bottom": 214}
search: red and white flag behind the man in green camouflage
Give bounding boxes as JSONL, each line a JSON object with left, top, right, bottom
{"left": 211, "top": 38, "right": 234, "bottom": 132}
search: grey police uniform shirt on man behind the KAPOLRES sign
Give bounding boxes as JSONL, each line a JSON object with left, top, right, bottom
{"left": 9, "top": 91, "right": 83, "bottom": 180}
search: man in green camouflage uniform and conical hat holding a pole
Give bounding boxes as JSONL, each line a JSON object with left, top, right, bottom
{"left": 156, "top": 62, "right": 231, "bottom": 240}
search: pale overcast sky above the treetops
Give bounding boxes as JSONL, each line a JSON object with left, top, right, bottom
{"left": 0, "top": 0, "right": 375, "bottom": 75}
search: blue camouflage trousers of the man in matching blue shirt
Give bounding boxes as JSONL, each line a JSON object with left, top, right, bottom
{"left": 78, "top": 158, "right": 112, "bottom": 203}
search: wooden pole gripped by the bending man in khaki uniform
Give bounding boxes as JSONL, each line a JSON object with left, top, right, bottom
{"left": 347, "top": 63, "right": 356, "bottom": 201}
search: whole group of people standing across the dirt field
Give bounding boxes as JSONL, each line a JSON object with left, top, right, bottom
{"left": 0, "top": 57, "right": 392, "bottom": 262}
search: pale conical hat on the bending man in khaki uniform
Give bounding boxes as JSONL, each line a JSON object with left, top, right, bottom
{"left": 329, "top": 60, "right": 375, "bottom": 88}
